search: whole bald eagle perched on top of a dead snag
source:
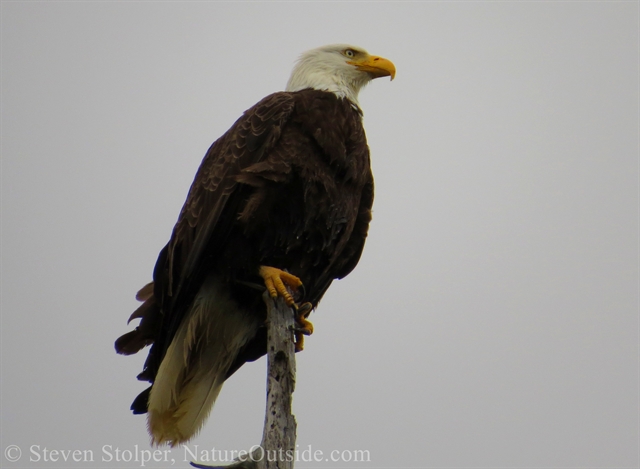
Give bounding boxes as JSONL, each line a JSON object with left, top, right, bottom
{"left": 115, "top": 45, "right": 395, "bottom": 446}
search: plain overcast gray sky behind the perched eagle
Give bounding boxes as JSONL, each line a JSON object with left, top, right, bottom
{"left": 0, "top": 1, "right": 640, "bottom": 469}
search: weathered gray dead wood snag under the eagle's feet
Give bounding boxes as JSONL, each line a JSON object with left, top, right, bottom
{"left": 191, "top": 292, "right": 296, "bottom": 469}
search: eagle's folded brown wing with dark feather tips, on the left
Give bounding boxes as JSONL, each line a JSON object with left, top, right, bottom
{"left": 115, "top": 93, "right": 294, "bottom": 392}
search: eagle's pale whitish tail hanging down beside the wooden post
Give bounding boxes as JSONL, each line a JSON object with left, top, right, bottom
{"left": 148, "top": 277, "right": 259, "bottom": 446}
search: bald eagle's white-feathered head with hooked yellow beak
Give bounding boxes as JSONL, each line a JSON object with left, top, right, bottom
{"left": 286, "top": 44, "right": 396, "bottom": 105}
